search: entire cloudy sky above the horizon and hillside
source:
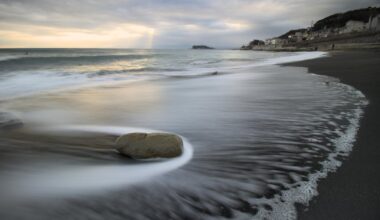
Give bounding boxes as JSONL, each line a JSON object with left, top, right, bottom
{"left": 0, "top": 0, "right": 379, "bottom": 49}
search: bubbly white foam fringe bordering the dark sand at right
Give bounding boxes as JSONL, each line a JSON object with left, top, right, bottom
{"left": 255, "top": 84, "right": 368, "bottom": 220}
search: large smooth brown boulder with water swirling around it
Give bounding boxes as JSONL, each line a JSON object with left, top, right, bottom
{"left": 116, "top": 133, "right": 183, "bottom": 159}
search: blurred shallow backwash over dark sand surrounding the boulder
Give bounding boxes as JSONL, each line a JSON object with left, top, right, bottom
{"left": 0, "top": 58, "right": 364, "bottom": 220}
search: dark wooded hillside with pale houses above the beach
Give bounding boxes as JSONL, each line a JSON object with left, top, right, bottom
{"left": 241, "top": 7, "right": 380, "bottom": 50}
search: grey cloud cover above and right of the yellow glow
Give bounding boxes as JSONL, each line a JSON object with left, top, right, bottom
{"left": 0, "top": 0, "right": 378, "bottom": 48}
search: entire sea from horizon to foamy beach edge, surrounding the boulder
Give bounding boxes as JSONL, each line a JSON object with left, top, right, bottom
{"left": 0, "top": 49, "right": 368, "bottom": 220}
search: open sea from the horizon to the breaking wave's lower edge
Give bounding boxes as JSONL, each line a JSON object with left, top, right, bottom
{"left": 0, "top": 49, "right": 321, "bottom": 100}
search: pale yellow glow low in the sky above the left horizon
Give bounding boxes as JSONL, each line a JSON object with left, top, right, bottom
{"left": 0, "top": 24, "right": 155, "bottom": 48}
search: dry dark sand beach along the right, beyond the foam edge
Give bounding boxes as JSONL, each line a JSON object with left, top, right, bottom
{"left": 288, "top": 51, "right": 380, "bottom": 220}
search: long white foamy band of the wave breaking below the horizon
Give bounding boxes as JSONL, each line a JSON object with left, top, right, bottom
{"left": 0, "top": 52, "right": 327, "bottom": 100}
